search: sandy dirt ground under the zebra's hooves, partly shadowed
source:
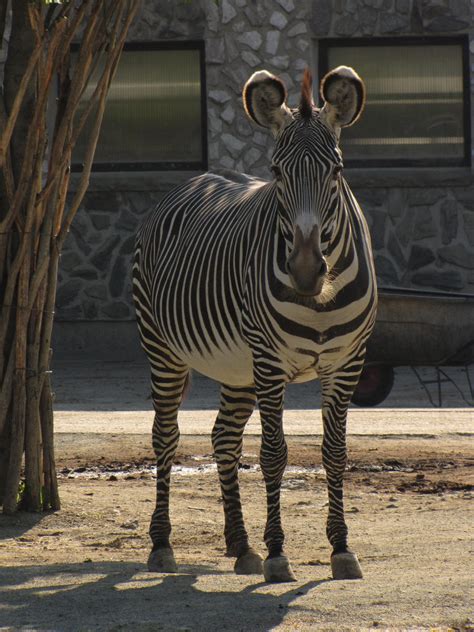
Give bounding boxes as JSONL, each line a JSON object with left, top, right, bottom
{"left": 0, "top": 434, "right": 474, "bottom": 632}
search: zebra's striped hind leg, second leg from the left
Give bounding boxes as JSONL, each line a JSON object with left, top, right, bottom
{"left": 212, "top": 384, "right": 263, "bottom": 575}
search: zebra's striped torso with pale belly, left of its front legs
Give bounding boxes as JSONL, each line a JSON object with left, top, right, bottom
{"left": 134, "top": 174, "right": 276, "bottom": 384}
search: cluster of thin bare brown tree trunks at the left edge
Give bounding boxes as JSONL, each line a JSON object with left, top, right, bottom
{"left": 0, "top": 0, "right": 139, "bottom": 513}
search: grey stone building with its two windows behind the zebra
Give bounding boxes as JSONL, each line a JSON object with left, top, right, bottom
{"left": 56, "top": 0, "right": 474, "bottom": 356}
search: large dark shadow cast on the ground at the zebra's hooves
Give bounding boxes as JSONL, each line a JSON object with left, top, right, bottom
{"left": 0, "top": 562, "right": 330, "bottom": 632}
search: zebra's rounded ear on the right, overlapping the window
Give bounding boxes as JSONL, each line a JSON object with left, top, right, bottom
{"left": 320, "top": 66, "right": 365, "bottom": 135}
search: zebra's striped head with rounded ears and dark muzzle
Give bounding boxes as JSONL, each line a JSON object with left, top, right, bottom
{"left": 243, "top": 66, "right": 365, "bottom": 297}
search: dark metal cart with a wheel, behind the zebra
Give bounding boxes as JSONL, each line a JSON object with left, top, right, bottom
{"left": 352, "top": 288, "right": 474, "bottom": 406}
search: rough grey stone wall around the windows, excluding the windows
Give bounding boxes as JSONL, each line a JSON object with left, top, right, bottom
{"left": 53, "top": 0, "right": 474, "bottom": 320}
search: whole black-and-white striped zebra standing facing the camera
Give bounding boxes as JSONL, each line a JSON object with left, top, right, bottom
{"left": 133, "top": 66, "right": 377, "bottom": 582}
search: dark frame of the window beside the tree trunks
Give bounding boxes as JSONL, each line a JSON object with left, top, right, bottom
{"left": 71, "top": 40, "right": 208, "bottom": 173}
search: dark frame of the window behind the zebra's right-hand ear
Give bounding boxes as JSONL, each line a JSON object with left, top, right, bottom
{"left": 317, "top": 34, "right": 472, "bottom": 171}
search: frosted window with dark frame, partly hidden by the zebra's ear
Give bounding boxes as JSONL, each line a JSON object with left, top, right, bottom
{"left": 319, "top": 37, "right": 470, "bottom": 167}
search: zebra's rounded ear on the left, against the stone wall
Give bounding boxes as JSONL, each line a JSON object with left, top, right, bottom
{"left": 242, "top": 70, "right": 293, "bottom": 136}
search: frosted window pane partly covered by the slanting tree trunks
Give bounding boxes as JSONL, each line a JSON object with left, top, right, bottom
{"left": 73, "top": 42, "right": 207, "bottom": 171}
